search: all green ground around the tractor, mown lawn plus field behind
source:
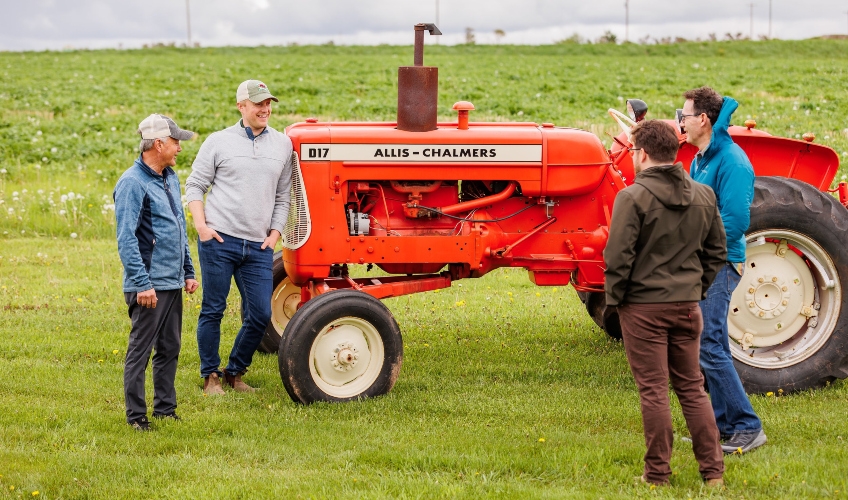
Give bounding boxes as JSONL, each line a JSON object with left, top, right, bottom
{"left": 0, "top": 40, "right": 848, "bottom": 499}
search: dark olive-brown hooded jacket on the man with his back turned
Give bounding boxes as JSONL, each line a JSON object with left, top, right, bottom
{"left": 604, "top": 163, "right": 727, "bottom": 306}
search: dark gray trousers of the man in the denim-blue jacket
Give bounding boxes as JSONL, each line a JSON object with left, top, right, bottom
{"left": 124, "top": 289, "right": 183, "bottom": 422}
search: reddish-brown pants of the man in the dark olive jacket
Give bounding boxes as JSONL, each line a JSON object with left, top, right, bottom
{"left": 618, "top": 302, "right": 724, "bottom": 484}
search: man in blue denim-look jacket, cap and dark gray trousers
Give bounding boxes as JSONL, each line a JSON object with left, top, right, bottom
{"left": 113, "top": 114, "right": 198, "bottom": 431}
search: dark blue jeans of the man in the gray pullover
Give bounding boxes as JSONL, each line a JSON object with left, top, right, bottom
{"left": 197, "top": 233, "right": 274, "bottom": 378}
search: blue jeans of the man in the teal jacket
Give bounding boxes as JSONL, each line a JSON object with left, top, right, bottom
{"left": 700, "top": 263, "right": 763, "bottom": 437}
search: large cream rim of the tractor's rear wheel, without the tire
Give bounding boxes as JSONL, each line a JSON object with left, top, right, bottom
{"left": 728, "top": 229, "right": 842, "bottom": 369}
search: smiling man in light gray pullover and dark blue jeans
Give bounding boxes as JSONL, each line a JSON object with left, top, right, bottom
{"left": 186, "top": 80, "right": 292, "bottom": 395}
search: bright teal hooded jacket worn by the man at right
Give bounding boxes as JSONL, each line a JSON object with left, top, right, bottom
{"left": 689, "top": 97, "right": 754, "bottom": 262}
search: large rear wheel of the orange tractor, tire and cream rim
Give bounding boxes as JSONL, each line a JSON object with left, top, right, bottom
{"left": 728, "top": 177, "right": 848, "bottom": 393}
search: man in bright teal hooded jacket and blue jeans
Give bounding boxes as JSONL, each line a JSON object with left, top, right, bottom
{"left": 680, "top": 87, "right": 766, "bottom": 453}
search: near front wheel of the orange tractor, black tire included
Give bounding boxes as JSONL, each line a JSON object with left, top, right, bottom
{"left": 278, "top": 290, "right": 403, "bottom": 404}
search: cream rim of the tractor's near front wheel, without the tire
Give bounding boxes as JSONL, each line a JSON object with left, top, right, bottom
{"left": 309, "top": 317, "right": 385, "bottom": 398}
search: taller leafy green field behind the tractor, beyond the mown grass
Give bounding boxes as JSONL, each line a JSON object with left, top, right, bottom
{"left": 0, "top": 40, "right": 848, "bottom": 239}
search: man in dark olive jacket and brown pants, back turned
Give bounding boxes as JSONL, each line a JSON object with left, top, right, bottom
{"left": 604, "top": 120, "right": 727, "bottom": 486}
